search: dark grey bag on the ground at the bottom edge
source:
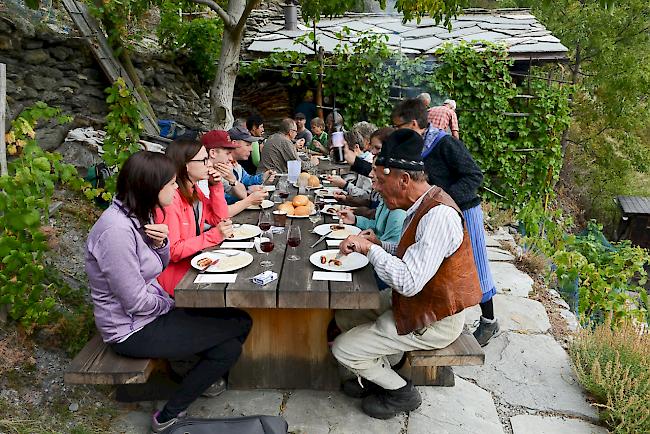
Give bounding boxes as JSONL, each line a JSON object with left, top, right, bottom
{"left": 163, "top": 416, "right": 289, "bottom": 434}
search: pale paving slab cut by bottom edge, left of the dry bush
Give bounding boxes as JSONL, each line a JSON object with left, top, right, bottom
{"left": 510, "top": 414, "right": 607, "bottom": 434}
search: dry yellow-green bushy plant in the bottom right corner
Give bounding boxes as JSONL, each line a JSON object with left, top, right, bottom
{"left": 570, "top": 323, "right": 650, "bottom": 434}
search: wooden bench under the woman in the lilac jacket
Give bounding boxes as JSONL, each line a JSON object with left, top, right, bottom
{"left": 63, "top": 335, "right": 158, "bottom": 385}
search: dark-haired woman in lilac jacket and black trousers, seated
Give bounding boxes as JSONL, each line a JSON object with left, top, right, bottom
{"left": 86, "top": 151, "right": 252, "bottom": 433}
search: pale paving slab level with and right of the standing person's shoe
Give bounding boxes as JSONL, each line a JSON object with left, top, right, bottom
{"left": 465, "top": 294, "right": 551, "bottom": 333}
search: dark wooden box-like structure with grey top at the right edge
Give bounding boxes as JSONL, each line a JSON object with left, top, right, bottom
{"left": 616, "top": 196, "right": 650, "bottom": 249}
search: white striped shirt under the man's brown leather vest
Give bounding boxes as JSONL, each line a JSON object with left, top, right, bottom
{"left": 368, "top": 187, "right": 463, "bottom": 297}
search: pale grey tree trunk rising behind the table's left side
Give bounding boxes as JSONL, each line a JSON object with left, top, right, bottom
{"left": 210, "top": 0, "right": 247, "bottom": 129}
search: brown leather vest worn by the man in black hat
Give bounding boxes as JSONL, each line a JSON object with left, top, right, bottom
{"left": 393, "top": 187, "right": 482, "bottom": 335}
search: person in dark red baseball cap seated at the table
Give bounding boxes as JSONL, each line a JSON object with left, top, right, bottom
{"left": 199, "top": 130, "right": 268, "bottom": 217}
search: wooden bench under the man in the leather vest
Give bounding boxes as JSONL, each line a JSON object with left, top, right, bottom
{"left": 404, "top": 333, "right": 485, "bottom": 387}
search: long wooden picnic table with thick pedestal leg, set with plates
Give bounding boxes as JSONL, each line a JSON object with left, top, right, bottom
{"left": 175, "top": 176, "right": 379, "bottom": 390}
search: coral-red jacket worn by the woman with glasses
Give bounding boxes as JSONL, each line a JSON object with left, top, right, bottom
{"left": 154, "top": 183, "right": 228, "bottom": 296}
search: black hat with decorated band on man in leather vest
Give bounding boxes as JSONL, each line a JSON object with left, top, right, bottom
{"left": 375, "top": 128, "right": 424, "bottom": 171}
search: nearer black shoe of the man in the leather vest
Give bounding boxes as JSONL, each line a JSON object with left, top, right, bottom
{"left": 361, "top": 380, "right": 422, "bottom": 419}
